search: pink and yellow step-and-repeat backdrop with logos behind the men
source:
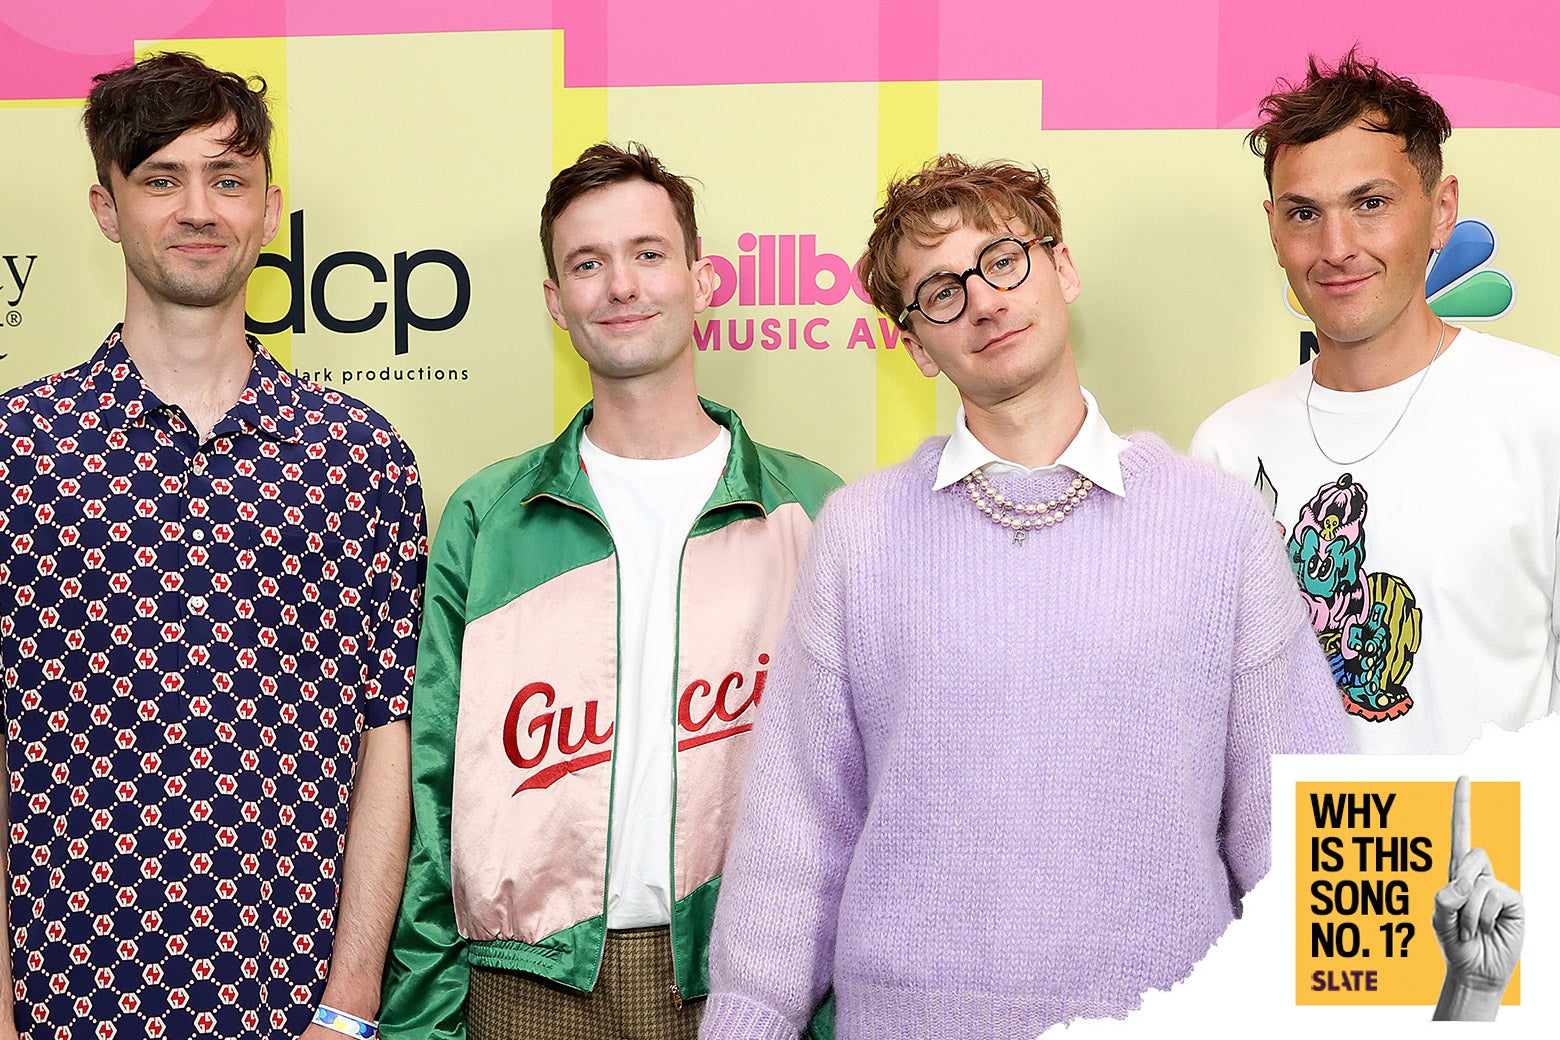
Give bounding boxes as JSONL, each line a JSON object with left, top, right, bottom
{"left": 0, "top": 0, "right": 1560, "bottom": 530}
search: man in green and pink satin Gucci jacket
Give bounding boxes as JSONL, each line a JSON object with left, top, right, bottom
{"left": 384, "top": 145, "right": 838, "bottom": 1040}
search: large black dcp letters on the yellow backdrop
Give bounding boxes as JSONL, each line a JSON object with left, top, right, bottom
{"left": 245, "top": 209, "right": 471, "bottom": 354}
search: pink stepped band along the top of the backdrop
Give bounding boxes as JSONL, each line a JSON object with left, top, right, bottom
{"left": 0, "top": 0, "right": 1560, "bottom": 129}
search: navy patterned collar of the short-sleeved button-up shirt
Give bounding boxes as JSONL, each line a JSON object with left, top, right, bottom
{"left": 83, "top": 327, "right": 303, "bottom": 443}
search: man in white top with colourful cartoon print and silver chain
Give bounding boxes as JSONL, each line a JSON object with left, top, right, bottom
{"left": 1192, "top": 51, "right": 1560, "bottom": 753}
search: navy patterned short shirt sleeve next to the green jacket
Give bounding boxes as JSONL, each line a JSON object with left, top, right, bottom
{"left": 363, "top": 430, "right": 427, "bottom": 727}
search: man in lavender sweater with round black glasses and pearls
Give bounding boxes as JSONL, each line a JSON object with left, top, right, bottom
{"left": 699, "top": 156, "right": 1349, "bottom": 1040}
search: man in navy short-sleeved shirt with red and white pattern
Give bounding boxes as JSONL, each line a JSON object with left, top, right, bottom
{"left": 0, "top": 55, "right": 424, "bottom": 1040}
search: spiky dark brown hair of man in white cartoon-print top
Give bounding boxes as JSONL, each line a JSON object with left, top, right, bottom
{"left": 1246, "top": 48, "right": 1452, "bottom": 193}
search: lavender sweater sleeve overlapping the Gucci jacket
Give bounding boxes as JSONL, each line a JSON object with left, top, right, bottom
{"left": 699, "top": 508, "right": 867, "bottom": 1040}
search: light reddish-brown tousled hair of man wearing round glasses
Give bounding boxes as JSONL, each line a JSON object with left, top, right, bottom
{"left": 858, "top": 154, "right": 1062, "bottom": 325}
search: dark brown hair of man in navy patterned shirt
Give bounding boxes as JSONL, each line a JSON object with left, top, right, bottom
{"left": 81, "top": 51, "right": 271, "bottom": 190}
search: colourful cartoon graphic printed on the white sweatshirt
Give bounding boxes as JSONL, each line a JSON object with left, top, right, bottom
{"left": 1257, "top": 460, "right": 1421, "bottom": 722}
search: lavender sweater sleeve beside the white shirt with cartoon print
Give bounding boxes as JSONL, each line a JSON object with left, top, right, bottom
{"left": 1220, "top": 510, "right": 1354, "bottom": 897}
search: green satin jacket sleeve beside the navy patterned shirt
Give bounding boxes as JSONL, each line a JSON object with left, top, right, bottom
{"left": 379, "top": 493, "right": 476, "bottom": 1040}
